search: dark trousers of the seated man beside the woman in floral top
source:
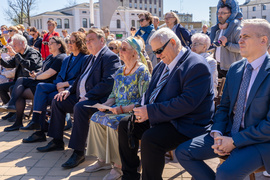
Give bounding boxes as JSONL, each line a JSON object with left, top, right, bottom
{"left": 48, "top": 94, "right": 97, "bottom": 151}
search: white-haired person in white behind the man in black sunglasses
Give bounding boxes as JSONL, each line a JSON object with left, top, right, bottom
{"left": 191, "top": 33, "right": 218, "bottom": 96}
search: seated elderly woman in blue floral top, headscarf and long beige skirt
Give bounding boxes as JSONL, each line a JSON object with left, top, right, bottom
{"left": 85, "top": 37, "right": 151, "bottom": 180}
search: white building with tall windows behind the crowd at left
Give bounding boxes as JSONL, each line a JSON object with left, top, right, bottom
{"left": 31, "top": 3, "right": 148, "bottom": 39}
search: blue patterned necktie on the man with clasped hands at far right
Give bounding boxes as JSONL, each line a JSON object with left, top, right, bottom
{"left": 231, "top": 64, "right": 253, "bottom": 135}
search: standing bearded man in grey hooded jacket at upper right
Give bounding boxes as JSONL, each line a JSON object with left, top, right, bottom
{"left": 214, "top": 5, "right": 242, "bottom": 78}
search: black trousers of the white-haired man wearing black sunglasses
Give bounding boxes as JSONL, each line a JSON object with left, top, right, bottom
{"left": 118, "top": 118, "right": 190, "bottom": 180}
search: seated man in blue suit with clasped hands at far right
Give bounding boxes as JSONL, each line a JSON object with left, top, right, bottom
{"left": 176, "top": 19, "right": 270, "bottom": 180}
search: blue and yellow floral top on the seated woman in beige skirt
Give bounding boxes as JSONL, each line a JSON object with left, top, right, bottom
{"left": 91, "top": 64, "right": 151, "bottom": 129}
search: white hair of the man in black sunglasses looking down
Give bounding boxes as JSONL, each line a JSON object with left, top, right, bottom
{"left": 149, "top": 27, "right": 181, "bottom": 47}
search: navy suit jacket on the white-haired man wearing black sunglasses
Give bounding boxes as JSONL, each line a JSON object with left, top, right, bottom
{"left": 145, "top": 49, "right": 214, "bottom": 138}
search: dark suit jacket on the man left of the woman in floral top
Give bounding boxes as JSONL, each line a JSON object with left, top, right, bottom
{"left": 70, "top": 46, "right": 120, "bottom": 103}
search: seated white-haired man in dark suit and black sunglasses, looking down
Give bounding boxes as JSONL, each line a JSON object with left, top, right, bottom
{"left": 118, "top": 28, "right": 214, "bottom": 180}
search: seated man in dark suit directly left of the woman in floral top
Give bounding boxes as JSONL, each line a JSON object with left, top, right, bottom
{"left": 37, "top": 28, "right": 120, "bottom": 168}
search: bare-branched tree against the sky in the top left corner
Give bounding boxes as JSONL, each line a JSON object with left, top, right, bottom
{"left": 5, "top": 0, "right": 38, "bottom": 26}
